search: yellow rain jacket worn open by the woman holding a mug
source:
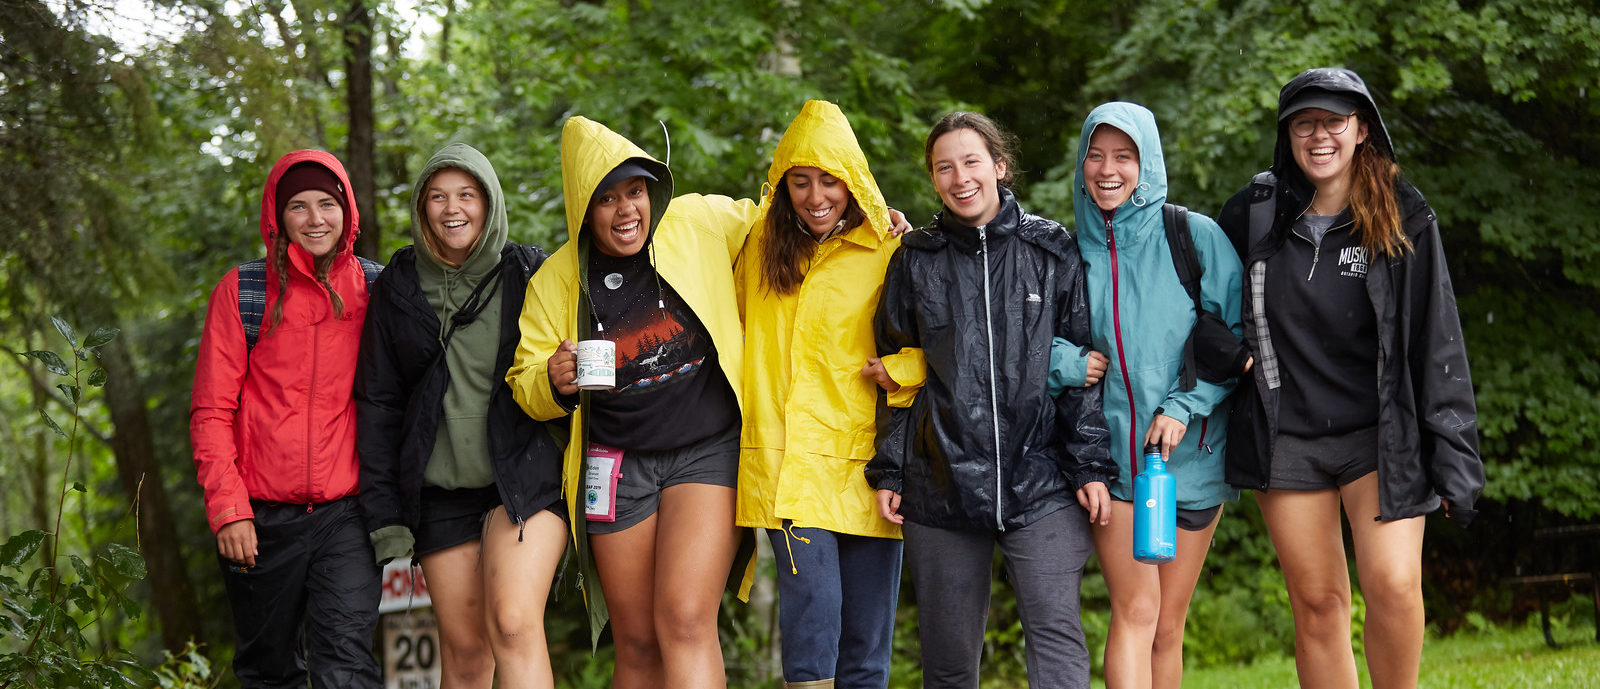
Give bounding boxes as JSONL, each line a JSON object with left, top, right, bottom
{"left": 506, "top": 117, "right": 757, "bottom": 643}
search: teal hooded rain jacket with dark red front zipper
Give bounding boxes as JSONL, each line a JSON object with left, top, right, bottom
{"left": 1051, "top": 102, "right": 1242, "bottom": 510}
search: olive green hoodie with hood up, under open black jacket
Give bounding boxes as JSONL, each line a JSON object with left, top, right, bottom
{"left": 411, "top": 144, "right": 507, "bottom": 489}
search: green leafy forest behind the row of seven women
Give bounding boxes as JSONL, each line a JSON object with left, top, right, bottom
{"left": 0, "top": 0, "right": 1600, "bottom": 686}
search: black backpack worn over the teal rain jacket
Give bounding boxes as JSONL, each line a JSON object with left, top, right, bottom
{"left": 1162, "top": 203, "right": 1250, "bottom": 390}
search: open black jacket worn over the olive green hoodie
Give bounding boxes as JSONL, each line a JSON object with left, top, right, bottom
{"left": 355, "top": 243, "right": 562, "bottom": 531}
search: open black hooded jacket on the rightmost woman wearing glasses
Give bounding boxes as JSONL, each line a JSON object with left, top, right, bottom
{"left": 1216, "top": 69, "right": 1485, "bottom": 526}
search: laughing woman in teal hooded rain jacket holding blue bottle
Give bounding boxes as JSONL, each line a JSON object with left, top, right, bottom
{"left": 1051, "top": 102, "right": 1242, "bottom": 689}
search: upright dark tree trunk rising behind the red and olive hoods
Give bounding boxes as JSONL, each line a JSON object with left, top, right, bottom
{"left": 344, "top": 0, "right": 382, "bottom": 261}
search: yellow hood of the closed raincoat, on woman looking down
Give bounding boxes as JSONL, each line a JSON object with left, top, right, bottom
{"left": 755, "top": 101, "right": 890, "bottom": 241}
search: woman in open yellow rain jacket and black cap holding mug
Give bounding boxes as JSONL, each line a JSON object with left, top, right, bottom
{"left": 506, "top": 117, "right": 757, "bottom": 689}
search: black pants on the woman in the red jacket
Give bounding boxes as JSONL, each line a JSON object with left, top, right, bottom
{"left": 218, "top": 497, "right": 382, "bottom": 689}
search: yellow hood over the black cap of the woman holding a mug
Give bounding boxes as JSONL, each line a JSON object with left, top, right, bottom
{"left": 562, "top": 115, "right": 672, "bottom": 241}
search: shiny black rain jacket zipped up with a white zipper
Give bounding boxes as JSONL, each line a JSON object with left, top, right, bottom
{"left": 867, "top": 189, "right": 1117, "bottom": 532}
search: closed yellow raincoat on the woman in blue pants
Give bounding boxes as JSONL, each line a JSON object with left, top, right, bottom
{"left": 738, "top": 101, "right": 923, "bottom": 539}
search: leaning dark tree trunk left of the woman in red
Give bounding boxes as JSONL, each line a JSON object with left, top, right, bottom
{"left": 99, "top": 342, "right": 202, "bottom": 652}
